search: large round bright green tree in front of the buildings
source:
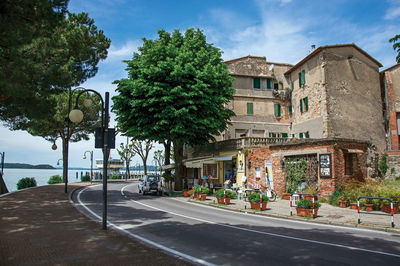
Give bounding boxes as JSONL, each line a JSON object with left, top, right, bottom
{"left": 113, "top": 29, "right": 234, "bottom": 190}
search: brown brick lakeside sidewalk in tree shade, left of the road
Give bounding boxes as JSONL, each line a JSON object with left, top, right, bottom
{"left": 0, "top": 184, "right": 189, "bottom": 265}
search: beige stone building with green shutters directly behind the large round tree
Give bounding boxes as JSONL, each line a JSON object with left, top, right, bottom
{"left": 218, "top": 55, "right": 292, "bottom": 140}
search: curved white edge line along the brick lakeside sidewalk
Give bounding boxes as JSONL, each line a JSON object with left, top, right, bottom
{"left": 77, "top": 185, "right": 215, "bottom": 266}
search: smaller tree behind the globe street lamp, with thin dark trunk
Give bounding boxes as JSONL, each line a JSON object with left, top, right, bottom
{"left": 24, "top": 90, "right": 101, "bottom": 184}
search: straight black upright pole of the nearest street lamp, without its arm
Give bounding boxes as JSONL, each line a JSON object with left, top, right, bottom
{"left": 103, "top": 92, "right": 110, "bottom": 230}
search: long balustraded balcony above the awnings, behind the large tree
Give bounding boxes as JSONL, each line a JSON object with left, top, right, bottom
{"left": 193, "top": 137, "right": 290, "bottom": 157}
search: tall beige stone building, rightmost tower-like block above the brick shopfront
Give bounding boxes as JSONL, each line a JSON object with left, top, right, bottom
{"left": 285, "top": 44, "right": 385, "bottom": 152}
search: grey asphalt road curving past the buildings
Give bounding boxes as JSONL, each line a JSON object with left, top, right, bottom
{"left": 74, "top": 183, "right": 400, "bottom": 265}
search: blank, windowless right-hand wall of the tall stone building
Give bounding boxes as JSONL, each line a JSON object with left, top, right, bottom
{"left": 323, "top": 48, "right": 386, "bottom": 151}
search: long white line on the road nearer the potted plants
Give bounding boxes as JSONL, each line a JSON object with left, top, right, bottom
{"left": 121, "top": 185, "right": 400, "bottom": 258}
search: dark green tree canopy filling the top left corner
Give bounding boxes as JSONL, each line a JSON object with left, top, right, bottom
{"left": 0, "top": 0, "right": 110, "bottom": 129}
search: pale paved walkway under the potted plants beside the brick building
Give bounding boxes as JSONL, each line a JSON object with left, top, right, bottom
{"left": 179, "top": 193, "right": 400, "bottom": 235}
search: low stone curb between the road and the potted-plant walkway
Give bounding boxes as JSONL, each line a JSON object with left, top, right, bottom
{"left": 189, "top": 198, "right": 400, "bottom": 236}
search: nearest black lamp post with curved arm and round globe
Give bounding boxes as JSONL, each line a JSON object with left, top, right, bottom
{"left": 69, "top": 89, "right": 110, "bottom": 230}
